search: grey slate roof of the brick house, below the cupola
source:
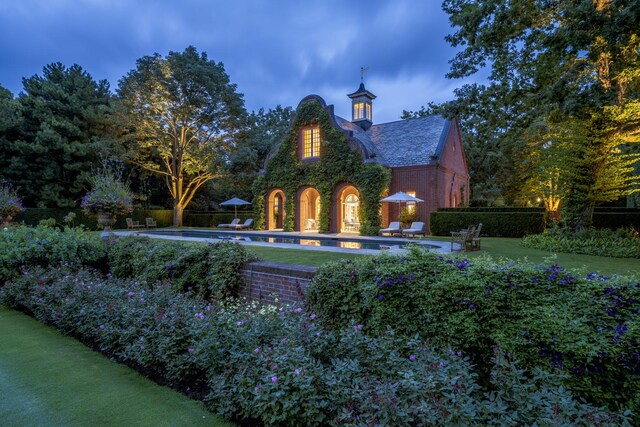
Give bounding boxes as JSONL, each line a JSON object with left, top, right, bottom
{"left": 335, "top": 116, "right": 451, "bottom": 167}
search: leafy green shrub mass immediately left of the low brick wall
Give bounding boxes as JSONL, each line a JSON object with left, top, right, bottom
{"left": 108, "top": 236, "right": 250, "bottom": 300}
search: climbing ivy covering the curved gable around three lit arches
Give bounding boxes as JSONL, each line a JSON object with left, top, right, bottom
{"left": 253, "top": 97, "right": 391, "bottom": 235}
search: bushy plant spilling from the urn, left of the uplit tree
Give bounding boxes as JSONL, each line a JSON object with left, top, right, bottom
{"left": 80, "top": 159, "right": 133, "bottom": 215}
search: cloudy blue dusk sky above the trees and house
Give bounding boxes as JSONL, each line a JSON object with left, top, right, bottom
{"left": 0, "top": 0, "right": 478, "bottom": 123}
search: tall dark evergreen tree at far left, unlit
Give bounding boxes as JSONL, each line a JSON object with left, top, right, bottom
{"left": 0, "top": 63, "right": 111, "bottom": 208}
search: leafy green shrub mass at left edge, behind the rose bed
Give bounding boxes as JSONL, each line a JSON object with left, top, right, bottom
{"left": 0, "top": 226, "right": 106, "bottom": 286}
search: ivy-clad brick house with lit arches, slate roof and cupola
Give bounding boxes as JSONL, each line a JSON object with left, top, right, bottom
{"left": 256, "top": 84, "right": 469, "bottom": 234}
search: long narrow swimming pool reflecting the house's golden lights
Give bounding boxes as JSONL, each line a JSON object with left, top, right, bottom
{"left": 144, "top": 230, "right": 439, "bottom": 251}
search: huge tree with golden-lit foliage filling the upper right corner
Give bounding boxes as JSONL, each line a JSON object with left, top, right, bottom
{"left": 443, "top": 0, "right": 640, "bottom": 227}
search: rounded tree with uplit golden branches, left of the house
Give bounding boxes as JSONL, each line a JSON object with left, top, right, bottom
{"left": 118, "top": 46, "right": 246, "bottom": 226}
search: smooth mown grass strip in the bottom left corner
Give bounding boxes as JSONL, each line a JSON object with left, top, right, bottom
{"left": 0, "top": 307, "right": 232, "bottom": 426}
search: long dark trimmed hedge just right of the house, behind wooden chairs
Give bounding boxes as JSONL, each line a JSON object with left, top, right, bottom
{"left": 429, "top": 211, "right": 546, "bottom": 237}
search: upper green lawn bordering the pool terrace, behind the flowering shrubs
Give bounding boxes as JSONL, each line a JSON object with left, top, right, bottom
{"left": 246, "top": 236, "right": 640, "bottom": 275}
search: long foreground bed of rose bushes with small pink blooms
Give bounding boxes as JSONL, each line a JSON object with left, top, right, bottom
{"left": 0, "top": 268, "right": 628, "bottom": 426}
